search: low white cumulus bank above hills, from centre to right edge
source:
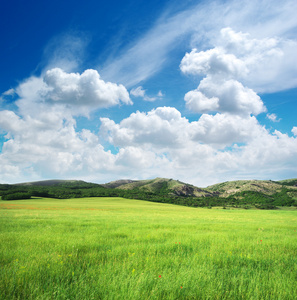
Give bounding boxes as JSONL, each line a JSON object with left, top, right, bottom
{"left": 100, "top": 107, "right": 297, "bottom": 185}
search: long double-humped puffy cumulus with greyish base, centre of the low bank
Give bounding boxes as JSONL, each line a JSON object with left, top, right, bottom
{"left": 101, "top": 107, "right": 265, "bottom": 152}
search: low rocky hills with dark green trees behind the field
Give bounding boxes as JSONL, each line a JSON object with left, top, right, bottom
{"left": 0, "top": 178, "right": 297, "bottom": 209}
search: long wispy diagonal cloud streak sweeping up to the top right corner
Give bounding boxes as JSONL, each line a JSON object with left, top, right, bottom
{"left": 100, "top": 0, "right": 297, "bottom": 88}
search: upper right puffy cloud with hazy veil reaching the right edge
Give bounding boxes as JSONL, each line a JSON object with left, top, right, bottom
{"left": 180, "top": 28, "right": 297, "bottom": 98}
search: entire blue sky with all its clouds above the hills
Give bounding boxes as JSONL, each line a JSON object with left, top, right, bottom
{"left": 0, "top": 0, "right": 297, "bottom": 187}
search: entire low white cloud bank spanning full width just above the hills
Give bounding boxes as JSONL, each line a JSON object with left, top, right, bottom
{"left": 0, "top": 107, "right": 297, "bottom": 186}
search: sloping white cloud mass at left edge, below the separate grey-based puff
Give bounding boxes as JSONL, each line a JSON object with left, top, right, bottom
{"left": 0, "top": 109, "right": 114, "bottom": 182}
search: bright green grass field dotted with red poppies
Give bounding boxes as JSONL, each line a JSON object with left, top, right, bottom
{"left": 0, "top": 198, "right": 297, "bottom": 300}
